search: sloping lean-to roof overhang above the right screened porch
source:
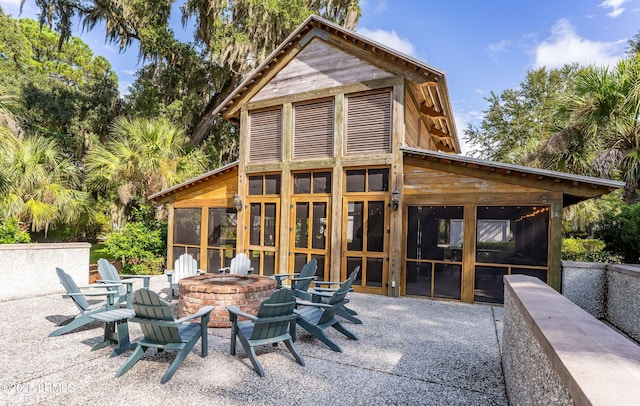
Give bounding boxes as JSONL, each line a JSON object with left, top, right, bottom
{"left": 401, "top": 147, "right": 625, "bottom": 207}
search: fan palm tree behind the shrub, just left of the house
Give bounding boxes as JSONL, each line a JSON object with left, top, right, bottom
{"left": 86, "top": 118, "right": 206, "bottom": 228}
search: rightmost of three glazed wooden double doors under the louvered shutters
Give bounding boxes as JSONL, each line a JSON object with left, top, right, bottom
{"left": 342, "top": 195, "right": 389, "bottom": 294}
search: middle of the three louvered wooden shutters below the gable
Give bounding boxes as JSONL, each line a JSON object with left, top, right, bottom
{"left": 293, "top": 100, "right": 333, "bottom": 159}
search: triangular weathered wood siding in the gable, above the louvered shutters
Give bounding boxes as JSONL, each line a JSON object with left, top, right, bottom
{"left": 251, "top": 38, "right": 395, "bottom": 102}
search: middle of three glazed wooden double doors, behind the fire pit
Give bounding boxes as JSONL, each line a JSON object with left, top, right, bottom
{"left": 289, "top": 197, "right": 331, "bottom": 280}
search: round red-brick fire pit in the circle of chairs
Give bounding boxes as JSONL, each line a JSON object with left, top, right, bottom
{"left": 178, "top": 274, "right": 277, "bottom": 327}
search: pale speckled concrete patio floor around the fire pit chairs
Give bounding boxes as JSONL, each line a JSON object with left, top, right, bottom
{"left": 0, "top": 276, "right": 508, "bottom": 405}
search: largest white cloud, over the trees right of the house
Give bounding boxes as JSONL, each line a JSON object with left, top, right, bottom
{"left": 534, "top": 18, "right": 625, "bottom": 68}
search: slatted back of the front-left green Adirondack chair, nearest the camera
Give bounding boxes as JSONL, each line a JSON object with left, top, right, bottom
{"left": 132, "top": 289, "right": 182, "bottom": 344}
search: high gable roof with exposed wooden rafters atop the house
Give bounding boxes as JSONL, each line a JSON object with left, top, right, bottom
{"left": 212, "top": 15, "right": 460, "bottom": 153}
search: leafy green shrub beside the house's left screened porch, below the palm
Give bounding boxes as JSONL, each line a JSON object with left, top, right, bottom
{"left": 104, "top": 221, "right": 166, "bottom": 275}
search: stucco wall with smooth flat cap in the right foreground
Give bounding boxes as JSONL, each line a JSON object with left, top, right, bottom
{"left": 502, "top": 275, "right": 640, "bottom": 405}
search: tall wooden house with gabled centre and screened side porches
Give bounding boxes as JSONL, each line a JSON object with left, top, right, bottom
{"left": 150, "top": 16, "right": 623, "bottom": 302}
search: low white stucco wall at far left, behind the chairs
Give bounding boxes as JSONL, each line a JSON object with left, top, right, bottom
{"left": 0, "top": 243, "right": 91, "bottom": 301}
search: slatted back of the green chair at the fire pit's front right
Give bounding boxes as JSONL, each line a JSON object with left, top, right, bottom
{"left": 251, "top": 289, "right": 296, "bottom": 340}
